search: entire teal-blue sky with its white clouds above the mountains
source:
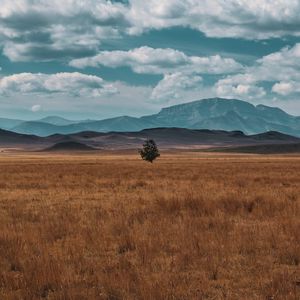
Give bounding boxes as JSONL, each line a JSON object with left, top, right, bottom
{"left": 0, "top": 0, "right": 300, "bottom": 120}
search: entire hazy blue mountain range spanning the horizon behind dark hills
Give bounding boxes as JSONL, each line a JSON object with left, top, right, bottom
{"left": 0, "top": 98, "right": 300, "bottom": 137}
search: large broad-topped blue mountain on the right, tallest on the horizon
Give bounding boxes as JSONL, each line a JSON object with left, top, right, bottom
{"left": 142, "top": 98, "right": 300, "bottom": 136}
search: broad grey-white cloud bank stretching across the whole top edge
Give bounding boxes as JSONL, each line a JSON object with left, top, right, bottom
{"left": 0, "top": 0, "right": 300, "bottom": 61}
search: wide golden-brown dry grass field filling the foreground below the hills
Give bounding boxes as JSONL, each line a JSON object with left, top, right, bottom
{"left": 0, "top": 153, "right": 300, "bottom": 300}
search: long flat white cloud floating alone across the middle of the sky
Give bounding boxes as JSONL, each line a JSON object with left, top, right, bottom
{"left": 70, "top": 46, "right": 242, "bottom": 74}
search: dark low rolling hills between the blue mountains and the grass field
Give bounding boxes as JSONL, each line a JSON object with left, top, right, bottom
{"left": 0, "top": 127, "right": 300, "bottom": 151}
